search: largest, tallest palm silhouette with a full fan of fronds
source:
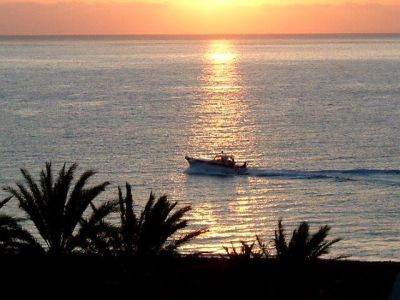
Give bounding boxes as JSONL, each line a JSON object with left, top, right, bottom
{"left": 4, "top": 162, "right": 115, "bottom": 255}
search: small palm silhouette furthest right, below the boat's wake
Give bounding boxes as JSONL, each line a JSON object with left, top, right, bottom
{"left": 274, "top": 220, "right": 341, "bottom": 261}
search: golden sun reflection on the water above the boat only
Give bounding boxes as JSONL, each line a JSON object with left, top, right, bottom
{"left": 189, "top": 40, "right": 249, "bottom": 158}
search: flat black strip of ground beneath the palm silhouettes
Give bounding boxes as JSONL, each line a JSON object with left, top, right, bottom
{"left": 0, "top": 256, "right": 400, "bottom": 300}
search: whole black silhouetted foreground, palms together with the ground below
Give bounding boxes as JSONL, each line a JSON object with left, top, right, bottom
{"left": 0, "top": 163, "right": 400, "bottom": 300}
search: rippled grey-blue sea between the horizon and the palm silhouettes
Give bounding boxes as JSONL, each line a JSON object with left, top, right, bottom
{"left": 0, "top": 35, "right": 400, "bottom": 261}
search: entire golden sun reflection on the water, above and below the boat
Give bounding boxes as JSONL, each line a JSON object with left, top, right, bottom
{"left": 184, "top": 40, "right": 278, "bottom": 253}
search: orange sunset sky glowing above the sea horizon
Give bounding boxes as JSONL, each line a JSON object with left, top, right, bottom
{"left": 0, "top": 0, "right": 400, "bottom": 35}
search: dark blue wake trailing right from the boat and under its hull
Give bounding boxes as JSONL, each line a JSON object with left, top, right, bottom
{"left": 187, "top": 166, "right": 400, "bottom": 186}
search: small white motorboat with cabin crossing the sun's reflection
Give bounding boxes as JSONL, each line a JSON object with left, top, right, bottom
{"left": 185, "top": 152, "right": 247, "bottom": 174}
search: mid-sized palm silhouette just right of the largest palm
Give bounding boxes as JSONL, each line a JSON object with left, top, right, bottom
{"left": 114, "top": 183, "right": 205, "bottom": 255}
